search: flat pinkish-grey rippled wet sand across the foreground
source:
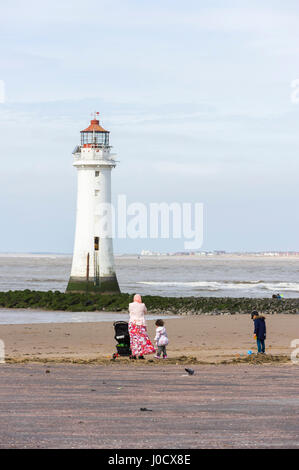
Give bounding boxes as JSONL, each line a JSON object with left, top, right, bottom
{"left": 0, "top": 364, "right": 299, "bottom": 449}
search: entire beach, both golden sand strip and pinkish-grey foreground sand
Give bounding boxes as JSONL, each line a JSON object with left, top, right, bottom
{"left": 0, "top": 315, "right": 299, "bottom": 449}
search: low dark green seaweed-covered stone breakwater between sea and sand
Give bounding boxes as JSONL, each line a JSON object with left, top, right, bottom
{"left": 0, "top": 290, "right": 299, "bottom": 315}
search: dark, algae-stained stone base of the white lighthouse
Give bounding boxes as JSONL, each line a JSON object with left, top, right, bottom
{"left": 66, "top": 274, "right": 120, "bottom": 294}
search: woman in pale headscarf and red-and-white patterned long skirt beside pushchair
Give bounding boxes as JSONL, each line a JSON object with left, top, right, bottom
{"left": 129, "top": 294, "right": 155, "bottom": 359}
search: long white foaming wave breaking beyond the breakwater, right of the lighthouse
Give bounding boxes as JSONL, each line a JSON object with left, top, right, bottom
{"left": 137, "top": 281, "right": 299, "bottom": 292}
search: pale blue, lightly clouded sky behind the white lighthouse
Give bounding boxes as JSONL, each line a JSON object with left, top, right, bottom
{"left": 0, "top": 0, "right": 299, "bottom": 253}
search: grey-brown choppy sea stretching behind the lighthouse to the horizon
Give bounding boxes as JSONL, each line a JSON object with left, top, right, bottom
{"left": 0, "top": 254, "right": 299, "bottom": 298}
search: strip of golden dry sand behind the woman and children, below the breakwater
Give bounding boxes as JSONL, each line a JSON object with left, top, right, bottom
{"left": 0, "top": 314, "right": 299, "bottom": 363}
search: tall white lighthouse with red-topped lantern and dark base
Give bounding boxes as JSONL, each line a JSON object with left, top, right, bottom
{"left": 67, "top": 113, "right": 120, "bottom": 293}
